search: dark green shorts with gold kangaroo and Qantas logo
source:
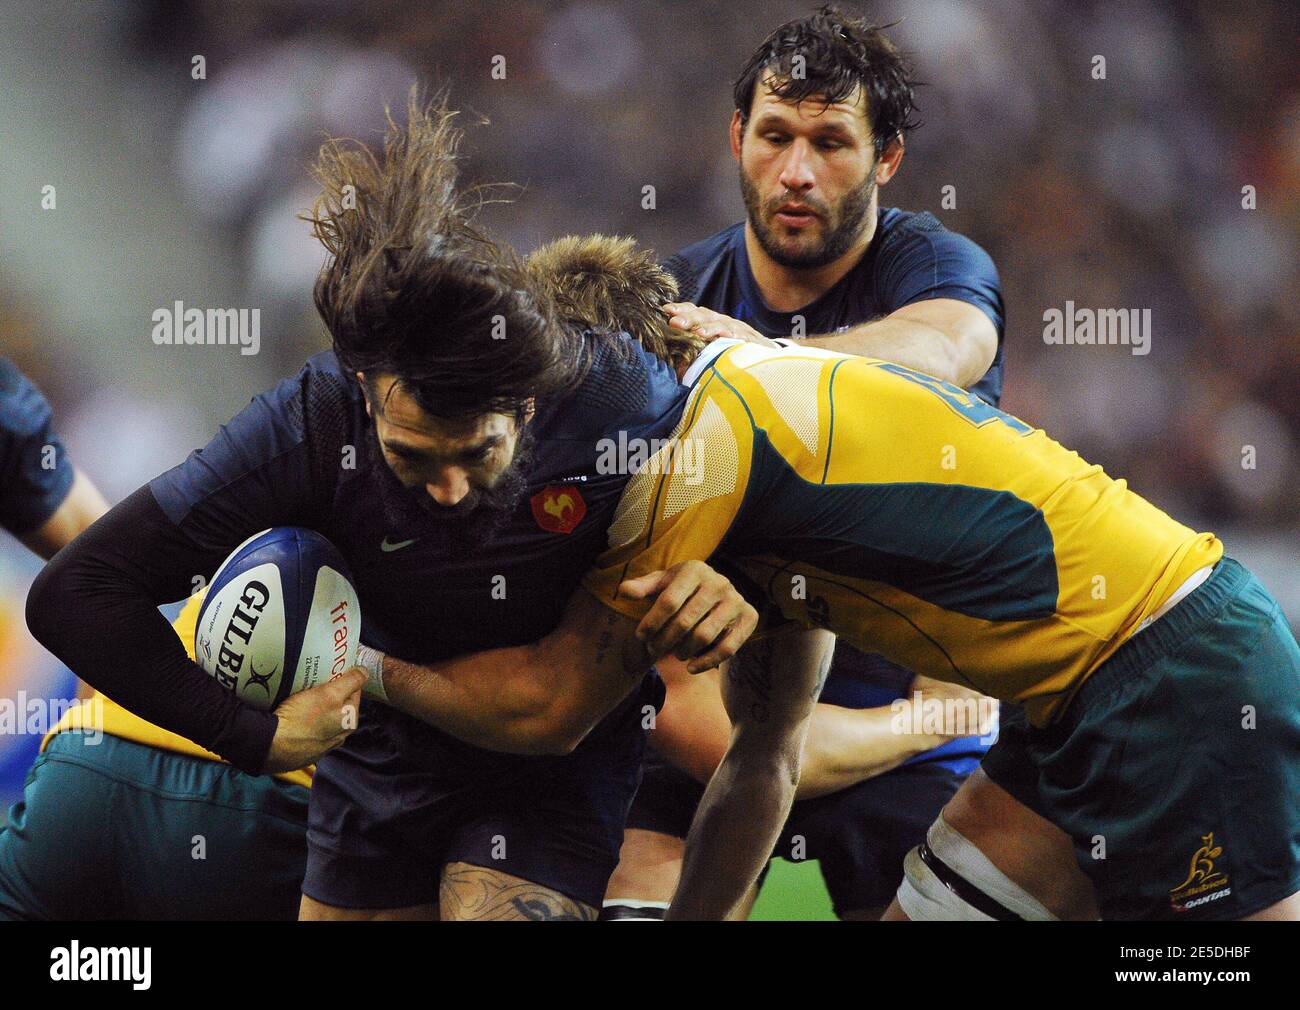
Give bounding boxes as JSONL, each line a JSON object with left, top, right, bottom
{"left": 984, "top": 559, "right": 1300, "bottom": 919}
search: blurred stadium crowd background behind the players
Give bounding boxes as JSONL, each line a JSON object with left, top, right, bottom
{"left": 0, "top": 0, "right": 1300, "bottom": 918}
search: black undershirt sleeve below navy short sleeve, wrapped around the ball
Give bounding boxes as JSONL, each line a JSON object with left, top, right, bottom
{"left": 27, "top": 486, "right": 278, "bottom": 775}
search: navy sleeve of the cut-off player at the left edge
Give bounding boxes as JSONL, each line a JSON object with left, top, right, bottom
{"left": 0, "top": 357, "right": 73, "bottom": 536}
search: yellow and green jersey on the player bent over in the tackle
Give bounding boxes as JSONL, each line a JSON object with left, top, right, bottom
{"left": 584, "top": 343, "right": 1223, "bottom": 725}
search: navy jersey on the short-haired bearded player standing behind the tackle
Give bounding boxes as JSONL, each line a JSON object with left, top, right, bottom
{"left": 663, "top": 207, "right": 1005, "bottom": 407}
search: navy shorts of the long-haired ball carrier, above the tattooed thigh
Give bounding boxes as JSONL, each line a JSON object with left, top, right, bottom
{"left": 303, "top": 675, "right": 663, "bottom": 909}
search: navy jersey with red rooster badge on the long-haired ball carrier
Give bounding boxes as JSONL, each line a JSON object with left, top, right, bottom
{"left": 150, "top": 334, "right": 686, "bottom": 662}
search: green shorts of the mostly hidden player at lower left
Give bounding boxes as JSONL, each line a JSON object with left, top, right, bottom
{"left": 0, "top": 733, "right": 308, "bottom": 919}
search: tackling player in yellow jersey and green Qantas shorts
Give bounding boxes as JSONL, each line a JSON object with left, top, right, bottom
{"left": 364, "top": 237, "right": 1300, "bottom": 919}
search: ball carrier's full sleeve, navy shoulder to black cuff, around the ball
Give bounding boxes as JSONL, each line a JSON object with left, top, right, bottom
{"left": 27, "top": 358, "right": 346, "bottom": 773}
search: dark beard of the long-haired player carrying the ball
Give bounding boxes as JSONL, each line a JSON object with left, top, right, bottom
{"left": 363, "top": 424, "right": 536, "bottom": 554}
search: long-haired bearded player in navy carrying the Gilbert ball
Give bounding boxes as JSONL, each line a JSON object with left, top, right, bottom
{"left": 27, "top": 97, "right": 757, "bottom": 919}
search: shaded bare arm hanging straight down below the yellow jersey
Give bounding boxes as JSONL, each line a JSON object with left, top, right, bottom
{"left": 667, "top": 634, "right": 831, "bottom": 919}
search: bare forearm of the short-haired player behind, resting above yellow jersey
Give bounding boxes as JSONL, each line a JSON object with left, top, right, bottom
{"left": 806, "top": 298, "right": 997, "bottom": 389}
